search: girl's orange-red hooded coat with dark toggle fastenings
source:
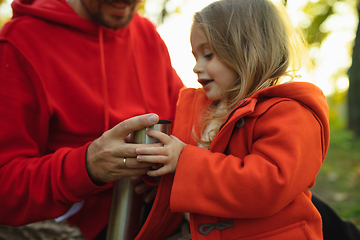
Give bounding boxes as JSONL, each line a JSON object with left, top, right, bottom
{"left": 139, "top": 82, "right": 329, "bottom": 240}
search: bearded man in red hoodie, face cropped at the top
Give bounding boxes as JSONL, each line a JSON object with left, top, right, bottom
{"left": 0, "top": 0, "right": 183, "bottom": 239}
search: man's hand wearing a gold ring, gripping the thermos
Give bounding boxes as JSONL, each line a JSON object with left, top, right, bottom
{"left": 86, "top": 114, "right": 161, "bottom": 184}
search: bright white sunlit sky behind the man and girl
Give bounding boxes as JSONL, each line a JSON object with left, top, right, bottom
{"left": 0, "top": 0, "right": 358, "bottom": 95}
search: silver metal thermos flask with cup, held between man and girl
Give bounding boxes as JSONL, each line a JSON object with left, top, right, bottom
{"left": 106, "top": 120, "right": 171, "bottom": 240}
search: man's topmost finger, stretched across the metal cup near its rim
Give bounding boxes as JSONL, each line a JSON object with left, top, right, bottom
{"left": 111, "top": 113, "right": 159, "bottom": 138}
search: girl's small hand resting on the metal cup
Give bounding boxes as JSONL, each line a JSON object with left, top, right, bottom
{"left": 136, "top": 130, "right": 186, "bottom": 177}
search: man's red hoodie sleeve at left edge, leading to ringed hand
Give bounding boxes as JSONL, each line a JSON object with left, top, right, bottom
{"left": 0, "top": 41, "right": 105, "bottom": 226}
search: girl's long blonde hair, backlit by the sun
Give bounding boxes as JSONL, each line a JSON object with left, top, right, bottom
{"left": 193, "top": 0, "right": 307, "bottom": 146}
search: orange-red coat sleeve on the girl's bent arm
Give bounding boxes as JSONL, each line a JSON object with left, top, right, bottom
{"left": 170, "top": 101, "right": 323, "bottom": 218}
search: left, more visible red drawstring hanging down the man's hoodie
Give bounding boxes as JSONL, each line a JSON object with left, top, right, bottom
{"left": 99, "top": 26, "right": 110, "bottom": 132}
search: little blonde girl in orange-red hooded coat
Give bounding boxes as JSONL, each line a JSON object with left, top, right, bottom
{"left": 137, "top": 0, "right": 329, "bottom": 240}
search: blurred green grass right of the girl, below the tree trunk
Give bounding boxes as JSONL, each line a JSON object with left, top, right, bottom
{"left": 312, "top": 125, "right": 360, "bottom": 228}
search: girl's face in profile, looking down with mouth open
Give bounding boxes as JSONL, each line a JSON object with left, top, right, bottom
{"left": 190, "top": 23, "right": 238, "bottom": 101}
